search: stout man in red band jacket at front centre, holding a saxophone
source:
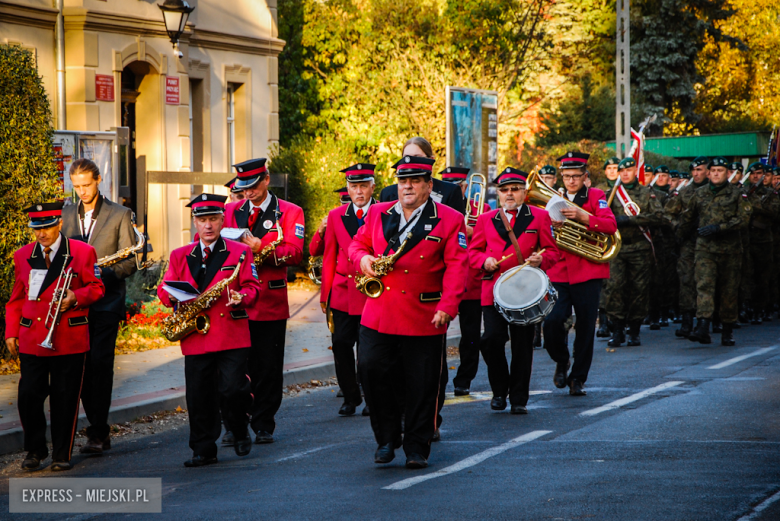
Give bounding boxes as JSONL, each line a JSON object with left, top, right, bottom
{"left": 349, "top": 155, "right": 466, "bottom": 468}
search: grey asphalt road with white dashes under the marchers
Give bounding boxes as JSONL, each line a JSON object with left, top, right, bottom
{"left": 0, "top": 321, "right": 780, "bottom": 521}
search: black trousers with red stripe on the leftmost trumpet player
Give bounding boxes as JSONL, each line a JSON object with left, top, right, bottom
{"left": 17, "top": 353, "right": 85, "bottom": 461}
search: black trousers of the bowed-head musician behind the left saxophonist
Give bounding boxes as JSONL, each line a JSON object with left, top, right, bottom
{"left": 249, "top": 320, "right": 287, "bottom": 434}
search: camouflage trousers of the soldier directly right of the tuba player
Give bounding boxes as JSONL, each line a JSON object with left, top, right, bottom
{"left": 606, "top": 249, "right": 653, "bottom": 323}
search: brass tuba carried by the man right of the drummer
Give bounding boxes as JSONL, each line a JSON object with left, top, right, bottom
{"left": 526, "top": 172, "right": 621, "bottom": 264}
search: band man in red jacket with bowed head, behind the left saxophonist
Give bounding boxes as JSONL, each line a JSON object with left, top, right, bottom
{"left": 222, "top": 158, "right": 304, "bottom": 445}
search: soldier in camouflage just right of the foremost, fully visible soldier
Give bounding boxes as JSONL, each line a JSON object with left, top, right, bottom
{"left": 745, "top": 162, "right": 780, "bottom": 325}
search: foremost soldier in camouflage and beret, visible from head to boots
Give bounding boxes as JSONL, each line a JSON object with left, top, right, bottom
{"left": 677, "top": 157, "right": 751, "bottom": 346}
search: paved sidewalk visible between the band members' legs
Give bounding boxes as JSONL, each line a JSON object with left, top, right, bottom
{"left": 0, "top": 290, "right": 460, "bottom": 454}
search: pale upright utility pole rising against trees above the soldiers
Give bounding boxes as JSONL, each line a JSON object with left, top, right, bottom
{"left": 615, "top": 0, "right": 631, "bottom": 158}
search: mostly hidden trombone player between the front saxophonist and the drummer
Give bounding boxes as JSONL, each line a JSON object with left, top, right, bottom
{"left": 441, "top": 166, "right": 490, "bottom": 396}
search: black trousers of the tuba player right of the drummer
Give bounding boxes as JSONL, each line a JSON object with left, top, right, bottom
{"left": 544, "top": 279, "right": 601, "bottom": 383}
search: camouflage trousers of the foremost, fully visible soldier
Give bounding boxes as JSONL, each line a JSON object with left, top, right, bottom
{"left": 696, "top": 250, "right": 742, "bottom": 324}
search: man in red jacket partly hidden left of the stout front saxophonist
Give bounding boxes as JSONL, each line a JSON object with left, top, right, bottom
{"left": 320, "top": 163, "right": 376, "bottom": 416}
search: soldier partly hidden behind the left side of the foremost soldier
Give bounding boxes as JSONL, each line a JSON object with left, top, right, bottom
{"left": 666, "top": 156, "right": 709, "bottom": 338}
